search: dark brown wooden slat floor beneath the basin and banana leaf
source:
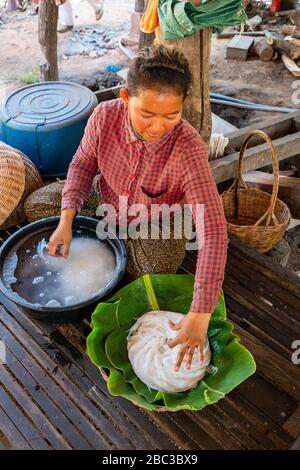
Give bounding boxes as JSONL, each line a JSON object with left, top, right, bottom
{"left": 0, "top": 230, "right": 300, "bottom": 450}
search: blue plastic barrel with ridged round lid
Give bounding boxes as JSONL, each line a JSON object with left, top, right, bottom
{"left": 0, "top": 82, "right": 98, "bottom": 178}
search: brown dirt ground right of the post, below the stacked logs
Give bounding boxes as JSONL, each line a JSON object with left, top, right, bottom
{"left": 210, "top": 37, "right": 300, "bottom": 127}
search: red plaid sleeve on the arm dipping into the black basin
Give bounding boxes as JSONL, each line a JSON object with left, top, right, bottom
{"left": 61, "top": 108, "right": 100, "bottom": 213}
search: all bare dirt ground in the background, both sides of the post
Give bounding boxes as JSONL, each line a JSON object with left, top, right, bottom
{"left": 0, "top": 0, "right": 300, "bottom": 127}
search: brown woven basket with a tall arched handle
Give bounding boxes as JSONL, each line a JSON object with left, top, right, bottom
{"left": 220, "top": 130, "right": 291, "bottom": 253}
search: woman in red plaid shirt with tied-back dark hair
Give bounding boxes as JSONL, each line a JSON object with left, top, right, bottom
{"left": 49, "top": 45, "right": 227, "bottom": 370}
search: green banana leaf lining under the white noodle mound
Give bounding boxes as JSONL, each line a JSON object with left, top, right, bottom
{"left": 87, "top": 274, "right": 255, "bottom": 410}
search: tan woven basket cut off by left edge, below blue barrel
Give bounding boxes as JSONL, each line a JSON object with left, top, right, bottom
{"left": 0, "top": 142, "right": 43, "bottom": 230}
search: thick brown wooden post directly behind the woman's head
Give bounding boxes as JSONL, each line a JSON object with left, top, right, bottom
{"left": 164, "top": 28, "right": 212, "bottom": 144}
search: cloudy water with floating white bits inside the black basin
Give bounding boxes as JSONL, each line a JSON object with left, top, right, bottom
{"left": 3, "top": 229, "right": 116, "bottom": 308}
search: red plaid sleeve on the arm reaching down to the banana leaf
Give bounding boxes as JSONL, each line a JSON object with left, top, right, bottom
{"left": 182, "top": 137, "right": 228, "bottom": 313}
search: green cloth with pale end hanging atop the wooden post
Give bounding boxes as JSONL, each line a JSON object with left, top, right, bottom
{"left": 158, "top": 0, "right": 247, "bottom": 39}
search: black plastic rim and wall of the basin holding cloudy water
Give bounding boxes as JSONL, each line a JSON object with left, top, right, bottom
{"left": 0, "top": 216, "right": 127, "bottom": 322}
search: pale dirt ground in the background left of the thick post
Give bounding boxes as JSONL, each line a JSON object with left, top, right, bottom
{"left": 0, "top": 0, "right": 134, "bottom": 97}
